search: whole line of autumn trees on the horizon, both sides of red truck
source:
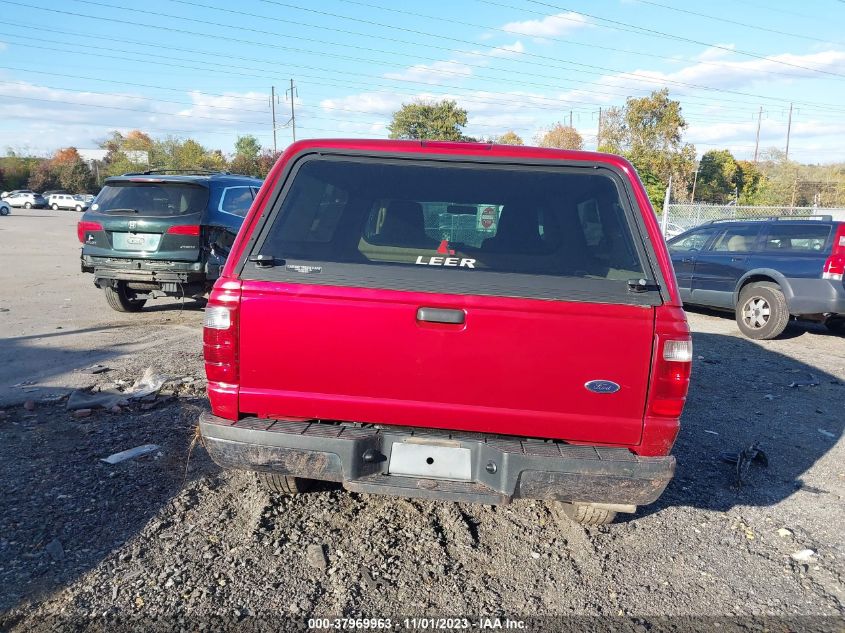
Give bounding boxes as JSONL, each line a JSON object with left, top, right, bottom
{"left": 0, "top": 89, "right": 845, "bottom": 209}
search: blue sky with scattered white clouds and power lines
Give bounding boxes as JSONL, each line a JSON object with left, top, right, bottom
{"left": 0, "top": 0, "right": 845, "bottom": 163}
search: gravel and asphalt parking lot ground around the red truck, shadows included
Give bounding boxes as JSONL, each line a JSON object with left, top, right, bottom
{"left": 0, "top": 210, "right": 845, "bottom": 629}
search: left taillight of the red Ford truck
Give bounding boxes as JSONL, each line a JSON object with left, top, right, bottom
{"left": 202, "top": 284, "right": 240, "bottom": 385}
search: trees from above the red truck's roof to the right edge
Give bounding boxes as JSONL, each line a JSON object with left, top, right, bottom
{"left": 388, "top": 89, "right": 845, "bottom": 209}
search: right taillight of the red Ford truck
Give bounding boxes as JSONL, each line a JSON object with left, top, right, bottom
{"left": 648, "top": 338, "right": 692, "bottom": 418}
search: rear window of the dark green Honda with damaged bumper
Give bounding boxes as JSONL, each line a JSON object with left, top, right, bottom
{"left": 91, "top": 182, "right": 209, "bottom": 216}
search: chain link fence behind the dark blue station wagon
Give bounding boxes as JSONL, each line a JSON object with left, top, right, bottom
{"left": 658, "top": 203, "right": 845, "bottom": 238}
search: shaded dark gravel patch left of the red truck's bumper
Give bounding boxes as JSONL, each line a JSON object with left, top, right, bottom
{"left": 0, "top": 398, "right": 216, "bottom": 616}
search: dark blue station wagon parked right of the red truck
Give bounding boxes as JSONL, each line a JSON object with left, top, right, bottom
{"left": 669, "top": 215, "right": 845, "bottom": 339}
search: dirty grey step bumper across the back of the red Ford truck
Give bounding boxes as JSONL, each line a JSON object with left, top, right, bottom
{"left": 199, "top": 413, "right": 675, "bottom": 511}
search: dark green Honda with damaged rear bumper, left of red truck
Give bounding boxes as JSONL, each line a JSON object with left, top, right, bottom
{"left": 77, "top": 170, "right": 262, "bottom": 312}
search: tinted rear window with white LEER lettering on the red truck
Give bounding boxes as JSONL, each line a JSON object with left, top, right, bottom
{"left": 254, "top": 159, "right": 644, "bottom": 280}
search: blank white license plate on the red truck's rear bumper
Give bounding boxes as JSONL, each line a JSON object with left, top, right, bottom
{"left": 387, "top": 440, "right": 472, "bottom": 481}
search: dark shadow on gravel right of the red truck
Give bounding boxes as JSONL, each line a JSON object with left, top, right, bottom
{"left": 640, "top": 333, "right": 845, "bottom": 520}
